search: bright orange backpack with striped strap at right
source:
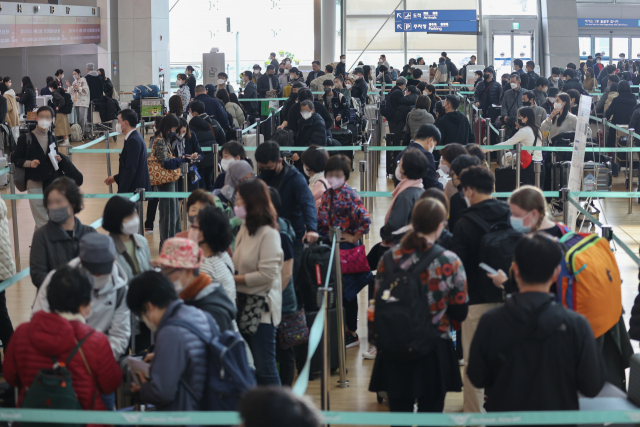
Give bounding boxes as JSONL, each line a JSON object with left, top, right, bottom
{"left": 557, "top": 231, "right": 622, "bottom": 338}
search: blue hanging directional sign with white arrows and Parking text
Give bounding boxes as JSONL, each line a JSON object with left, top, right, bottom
{"left": 394, "top": 9, "right": 478, "bottom": 33}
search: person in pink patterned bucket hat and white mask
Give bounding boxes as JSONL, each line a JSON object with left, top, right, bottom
{"left": 153, "top": 237, "right": 237, "bottom": 332}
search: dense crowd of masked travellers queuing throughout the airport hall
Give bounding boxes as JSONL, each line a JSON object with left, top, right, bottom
{"left": 0, "top": 52, "right": 640, "bottom": 426}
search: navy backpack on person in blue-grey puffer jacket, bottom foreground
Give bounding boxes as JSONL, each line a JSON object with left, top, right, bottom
{"left": 167, "top": 312, "right": 256, "bottom": 411}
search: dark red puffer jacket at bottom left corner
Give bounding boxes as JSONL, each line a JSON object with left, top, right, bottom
{"left": 3, "top": 311, "right": 122, "bottom": 411}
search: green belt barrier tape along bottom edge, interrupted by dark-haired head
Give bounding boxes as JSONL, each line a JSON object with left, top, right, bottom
{"left": 5, "top": 408, "right": 640, "bottom": 426}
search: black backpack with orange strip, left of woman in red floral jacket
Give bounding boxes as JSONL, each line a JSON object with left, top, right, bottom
{"left": 293, "top": 244, "right": 335, "bottom": 313}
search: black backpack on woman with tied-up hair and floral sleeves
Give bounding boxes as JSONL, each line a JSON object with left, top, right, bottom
{"left": 374, "top": 244, "right": 444, "bottom": 360}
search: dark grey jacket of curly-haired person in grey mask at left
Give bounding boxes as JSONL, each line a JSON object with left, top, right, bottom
{"left": 29, "top": 218, "right": 96, "bottom": 288}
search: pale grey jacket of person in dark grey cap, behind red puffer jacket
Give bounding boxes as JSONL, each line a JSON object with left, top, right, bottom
{"left": 32, "top": 257, "right": 131, "bottom": 360}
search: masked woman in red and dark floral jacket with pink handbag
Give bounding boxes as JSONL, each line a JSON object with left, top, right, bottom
{"left": 318, "top": 154, "right": 373, "bottom": 348}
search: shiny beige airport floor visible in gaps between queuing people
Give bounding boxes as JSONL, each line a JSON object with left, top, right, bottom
{"left": 2, "top": 131, "right": 640, "bottom": 422}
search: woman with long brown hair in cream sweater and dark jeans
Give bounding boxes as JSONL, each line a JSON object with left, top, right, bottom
{"left": 233, "top": 179, "right": 284, "bottom": 386}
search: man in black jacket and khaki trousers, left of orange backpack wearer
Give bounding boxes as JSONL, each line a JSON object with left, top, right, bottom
{"left": 451, "top": 166, "right": 510, "bottom": 412}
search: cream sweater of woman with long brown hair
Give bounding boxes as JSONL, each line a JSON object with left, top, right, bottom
{"left": 233, "top": 223, "right": 284, "bottom": 326}
